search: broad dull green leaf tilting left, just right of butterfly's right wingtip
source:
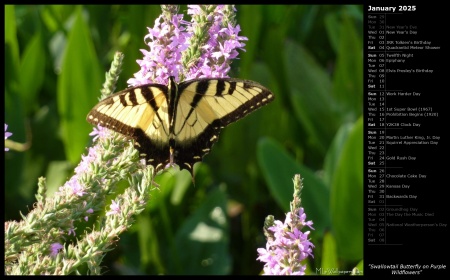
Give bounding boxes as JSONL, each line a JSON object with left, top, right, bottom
{"left": 284, "top": 41, "right": 340, "bottom": 156}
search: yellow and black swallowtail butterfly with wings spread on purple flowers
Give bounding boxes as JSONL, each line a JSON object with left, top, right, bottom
{"left": 87, "top": 77, "right": 274, "bottom": 177}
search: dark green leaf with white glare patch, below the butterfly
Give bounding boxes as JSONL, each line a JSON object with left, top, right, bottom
{"left": 170, "top": 189, "right": 231, "bottom": 275}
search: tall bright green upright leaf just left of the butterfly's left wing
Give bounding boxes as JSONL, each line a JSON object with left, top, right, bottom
{"left": 58, "top": 9, "right": 102, "bottom": 164}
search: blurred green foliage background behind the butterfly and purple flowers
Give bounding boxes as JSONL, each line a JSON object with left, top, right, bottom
{"left": 4, "top": 5, "right": 363, "bottom": 275}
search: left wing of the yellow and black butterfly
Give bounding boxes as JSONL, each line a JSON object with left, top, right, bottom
{"left": 87, "top": 84, "right": 170, "bottom": 170}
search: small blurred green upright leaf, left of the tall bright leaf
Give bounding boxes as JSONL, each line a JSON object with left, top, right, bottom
{"left": 19, "top": 32, "right": 46, "bottom": 113}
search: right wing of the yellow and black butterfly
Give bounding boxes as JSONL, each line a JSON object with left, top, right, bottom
{"left": 173, "top": 78, "right": 274, "bottom": 174}
